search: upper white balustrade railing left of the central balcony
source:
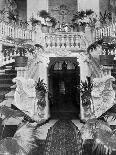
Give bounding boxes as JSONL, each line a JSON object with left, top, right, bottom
{"left": 0, "top": 21, "right": 33, "bottom": 40}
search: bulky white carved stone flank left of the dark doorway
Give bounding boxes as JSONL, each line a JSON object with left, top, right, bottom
{"left": 13, "top": 77, "right": 37, "bottom": 117}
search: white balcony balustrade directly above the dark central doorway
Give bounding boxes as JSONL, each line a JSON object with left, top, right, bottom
{"left": 44, "top": 32, "right": 88, "bottom": 51}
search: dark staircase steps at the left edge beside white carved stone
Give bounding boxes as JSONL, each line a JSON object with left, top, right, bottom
{"left": 0, "top": 63, "right": 17, "bottom": 106}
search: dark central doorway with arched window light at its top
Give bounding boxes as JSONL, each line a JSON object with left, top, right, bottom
{"left": 48, "top": 57, "right": 80, "bottom": 119}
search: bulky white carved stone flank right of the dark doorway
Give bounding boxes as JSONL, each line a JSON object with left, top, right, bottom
{"left": 91, "top": 75, "right": 115, "bottom": 117}
